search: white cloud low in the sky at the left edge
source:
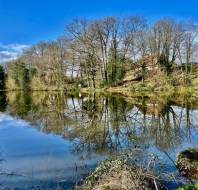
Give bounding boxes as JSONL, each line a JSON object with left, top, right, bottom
{"left": 0, "top": 42, "right": 29, "bottom": 63}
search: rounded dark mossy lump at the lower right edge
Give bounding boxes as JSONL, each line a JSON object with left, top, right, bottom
{"left": 177, "top": 148, "right": 198, "bottom": 180}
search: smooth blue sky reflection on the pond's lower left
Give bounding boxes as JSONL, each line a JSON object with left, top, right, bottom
{"left": 0, "top": 114, "right": 103, "bottom": 189}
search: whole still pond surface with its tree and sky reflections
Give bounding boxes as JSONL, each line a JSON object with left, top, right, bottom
{"left": 0, "top": 92, "right": 198, "bottom": 190}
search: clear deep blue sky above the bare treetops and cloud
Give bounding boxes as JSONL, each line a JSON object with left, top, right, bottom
{"left": 0, "top": 0, "right": 198, "bottom": 62}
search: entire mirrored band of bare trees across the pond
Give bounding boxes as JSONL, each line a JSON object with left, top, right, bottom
{"left": 5, "top": 92, "right": 196, "bottom": 157}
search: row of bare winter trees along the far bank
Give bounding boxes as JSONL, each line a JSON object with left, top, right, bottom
{"left": 4, "top": 16, "right": 198, "bottom": 89}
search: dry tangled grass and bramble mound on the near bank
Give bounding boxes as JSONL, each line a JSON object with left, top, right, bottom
{"left": 80, "top": 159, "right": 166, "bottom": 190}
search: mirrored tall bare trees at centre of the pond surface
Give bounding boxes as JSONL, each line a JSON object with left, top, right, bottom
{"left": 67, "top": 94, "right": 134, "bottom": 157}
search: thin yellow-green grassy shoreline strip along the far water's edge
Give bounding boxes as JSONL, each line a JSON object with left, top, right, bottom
{"left": 3, "top": 86, "right": 198, "bottom": 98}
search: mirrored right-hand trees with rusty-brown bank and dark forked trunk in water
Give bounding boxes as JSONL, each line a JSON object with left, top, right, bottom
{"left": 134, "top": 96, "right": 194, "bottom": 150}
